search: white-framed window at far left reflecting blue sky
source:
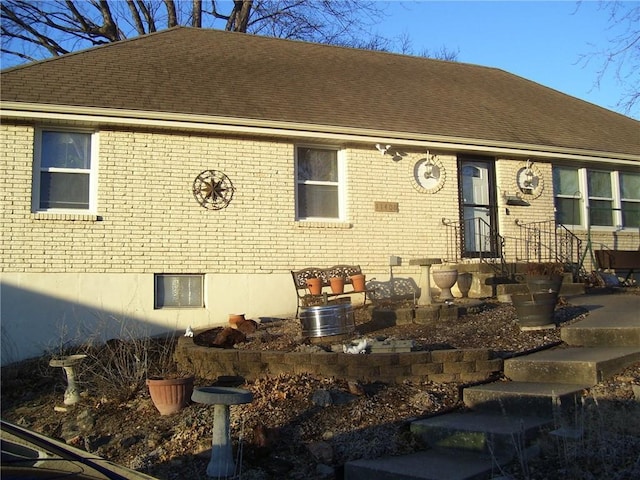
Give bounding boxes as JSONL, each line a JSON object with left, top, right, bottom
{"left": 33, "top": 130, "right": 97, "bottom": 211}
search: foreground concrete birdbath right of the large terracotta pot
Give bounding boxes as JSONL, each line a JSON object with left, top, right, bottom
{"left": 191, "top": 386, "right": 253, "bottom": 478}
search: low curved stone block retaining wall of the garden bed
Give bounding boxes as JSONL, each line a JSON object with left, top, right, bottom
{"left": 175, "top": 337, "right": 502, "bottom": 383}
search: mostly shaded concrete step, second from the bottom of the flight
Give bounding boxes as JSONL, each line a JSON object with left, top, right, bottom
{"left": 411, "top": 412, "right": 553, "bottom": 459}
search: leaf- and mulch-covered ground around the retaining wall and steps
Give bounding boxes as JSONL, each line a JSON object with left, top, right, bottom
{"left": 2, "top": 290, "right": 640, "bottom": 480}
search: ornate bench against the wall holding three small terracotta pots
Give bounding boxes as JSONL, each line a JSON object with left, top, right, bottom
{"left": 291, "top": 265, "right": 368, "bottom": 318}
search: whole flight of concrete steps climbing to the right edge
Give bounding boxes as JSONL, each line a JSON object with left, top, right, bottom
{"left": 344, "top": 293, "right": 640, "bottom": 480}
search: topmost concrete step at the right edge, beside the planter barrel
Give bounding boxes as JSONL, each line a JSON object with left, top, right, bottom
{"left": 560, "top": 312, "right": 640, "bottom": 347}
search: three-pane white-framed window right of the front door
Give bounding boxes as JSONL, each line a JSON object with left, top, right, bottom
{"left": 553, "top": 166, "right": 640, "bottom": 228}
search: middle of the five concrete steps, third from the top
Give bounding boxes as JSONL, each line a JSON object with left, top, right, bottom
{"left": 462, "top": 382, "right": 591, "bottom": 417}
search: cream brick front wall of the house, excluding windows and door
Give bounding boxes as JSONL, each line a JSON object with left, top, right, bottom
{"left": 0, "top": 122, "right": 637, "bottom": 362}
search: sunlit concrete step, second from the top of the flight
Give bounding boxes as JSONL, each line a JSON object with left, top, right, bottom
{"left": 504, "top": 347, "right": 640, "bottom": 385}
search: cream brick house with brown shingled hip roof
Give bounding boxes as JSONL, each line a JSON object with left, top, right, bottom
{"left": 0, "top": 27, "right": 640, "bottom": 364}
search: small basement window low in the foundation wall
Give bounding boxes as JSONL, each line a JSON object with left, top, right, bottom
{"left": 155, "top": 274, "right": 204, "bottom": 308}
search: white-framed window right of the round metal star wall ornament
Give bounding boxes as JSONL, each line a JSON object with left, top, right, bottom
{"left": 296, "top": 147, "right": 342, "bottom": 220}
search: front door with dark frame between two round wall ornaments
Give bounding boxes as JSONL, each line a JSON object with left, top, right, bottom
{"left": 459, "top": 158, "right": 496, "bottom": 257}
